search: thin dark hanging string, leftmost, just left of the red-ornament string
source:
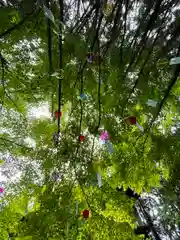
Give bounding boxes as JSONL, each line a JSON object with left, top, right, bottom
{"left": 46, "top": 0, "right": 54, "bottom": 117}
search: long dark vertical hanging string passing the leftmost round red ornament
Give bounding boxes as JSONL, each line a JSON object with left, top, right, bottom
{"left": 57, "top": 0, "right": 64, "bottom": 136}
